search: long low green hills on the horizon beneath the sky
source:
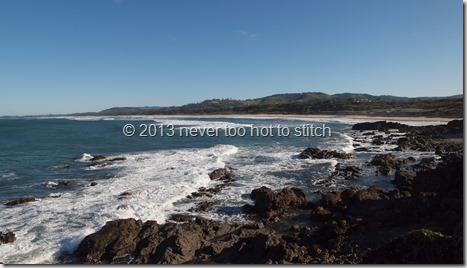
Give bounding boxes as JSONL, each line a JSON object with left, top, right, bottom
{"left": 78, "top": 92, "right": 464, "bottom": 117}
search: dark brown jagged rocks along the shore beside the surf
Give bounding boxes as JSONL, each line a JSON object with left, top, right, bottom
{"left": 64, "top": 120, "right": 464, "bottom": 264}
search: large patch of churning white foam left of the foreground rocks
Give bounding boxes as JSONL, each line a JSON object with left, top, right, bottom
{"left": 0, "top": 145, "right": 238, "bottom": 263}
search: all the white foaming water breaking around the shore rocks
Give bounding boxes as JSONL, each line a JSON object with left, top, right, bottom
{"left": 0, "top": 118, "right": 442, "bottom": 263}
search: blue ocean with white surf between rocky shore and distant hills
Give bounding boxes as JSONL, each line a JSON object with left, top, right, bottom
{"left": 0, "top": 116, "right": 439, "bottom": 264}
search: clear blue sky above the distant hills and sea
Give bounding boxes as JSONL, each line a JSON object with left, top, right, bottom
{"left": 0, "top": 0, "right": 463, "bottom": 116}
